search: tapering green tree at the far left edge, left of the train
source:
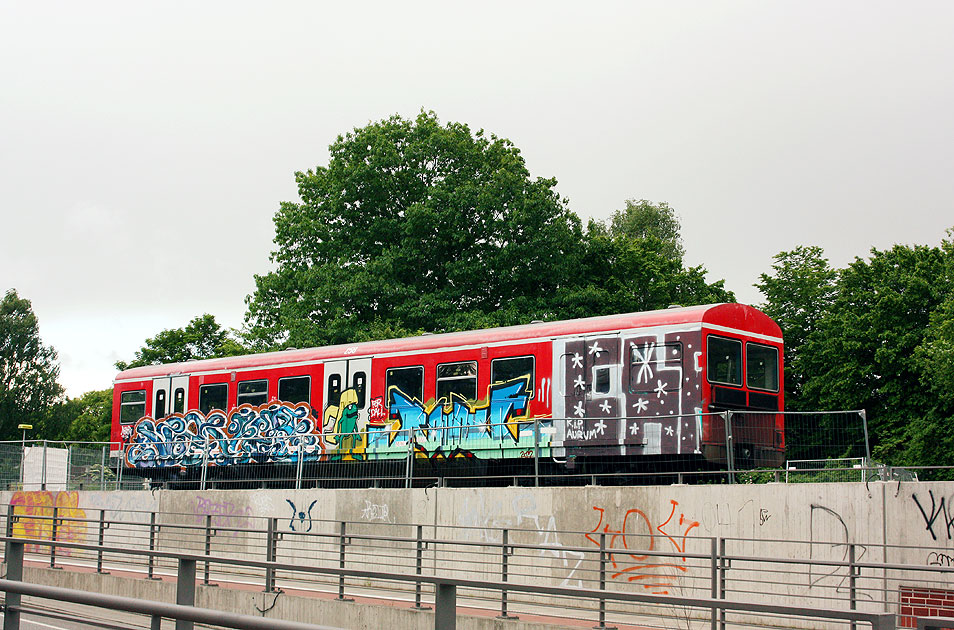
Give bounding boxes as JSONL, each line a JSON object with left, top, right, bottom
{"left": 0, "top": 289, "right": 63, "bottom": 440}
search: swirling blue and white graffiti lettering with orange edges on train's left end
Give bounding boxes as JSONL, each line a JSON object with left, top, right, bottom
{"left": 126, "top": 402, "right": 324, "bottom": 468}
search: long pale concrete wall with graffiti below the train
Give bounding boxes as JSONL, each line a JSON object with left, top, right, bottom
{"left": 0, "top": 482, "right": 954, "bottom": 627}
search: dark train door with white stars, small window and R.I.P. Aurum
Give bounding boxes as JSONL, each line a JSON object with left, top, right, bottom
{"left": 561, "top": 333, "right": 625, "bottom": 454}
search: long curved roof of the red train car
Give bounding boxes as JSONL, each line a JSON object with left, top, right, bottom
{"left": 114, "top": 304, "right": 782, "bottom": 383}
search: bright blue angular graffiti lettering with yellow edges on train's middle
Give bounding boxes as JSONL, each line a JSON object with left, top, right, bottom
{"left": 388, "top": 376, "right": 532, "bottom": 444}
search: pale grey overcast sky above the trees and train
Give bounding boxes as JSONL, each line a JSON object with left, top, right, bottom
{"left": 0, "top": 0, "right": 954, "bottom": 396}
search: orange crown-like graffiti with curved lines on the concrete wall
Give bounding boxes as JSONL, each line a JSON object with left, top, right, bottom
{"left": 585, "top": 500, "right": 699, "bottom": 595}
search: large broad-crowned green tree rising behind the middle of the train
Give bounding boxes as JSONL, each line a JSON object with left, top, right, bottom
{"left": 246, "top": 112, "right": 583, "bottom": 347}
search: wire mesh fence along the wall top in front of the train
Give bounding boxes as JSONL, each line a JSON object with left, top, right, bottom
{"left": 0, "top": 411, "right": 898, "bottom": 490}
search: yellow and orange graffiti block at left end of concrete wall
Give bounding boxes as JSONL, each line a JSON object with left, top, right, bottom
{"left": 10, "top": 490, "right": 86, "bottom": 556}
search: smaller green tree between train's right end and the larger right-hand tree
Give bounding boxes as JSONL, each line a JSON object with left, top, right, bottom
{"left": 755, "top": 246, "right": 838, "bottom": 410}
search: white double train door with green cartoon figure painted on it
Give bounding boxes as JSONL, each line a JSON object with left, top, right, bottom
{"left": 322, "top": 357, "right": 371, "bottom": 459}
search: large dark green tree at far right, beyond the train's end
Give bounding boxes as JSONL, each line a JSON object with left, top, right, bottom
{"left": 799, "top": 245, "right": 954, "bottom": 464}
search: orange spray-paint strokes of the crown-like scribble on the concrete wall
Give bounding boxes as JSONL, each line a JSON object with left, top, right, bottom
{"left": 585, "top": 500, "right": 699, "bottom": 595}
